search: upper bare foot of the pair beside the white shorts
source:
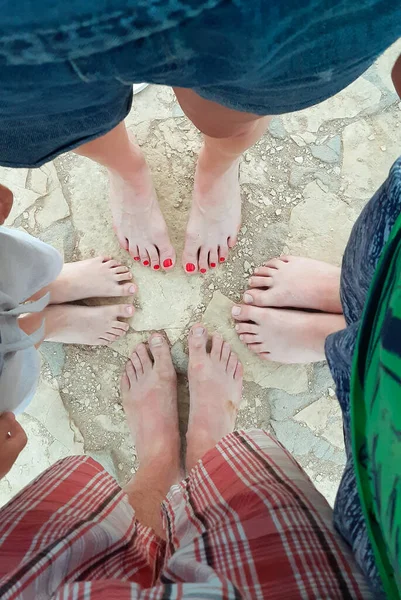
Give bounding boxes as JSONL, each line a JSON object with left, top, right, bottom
{"left": 48, "top": 256, "right": 136, "bottom": 304}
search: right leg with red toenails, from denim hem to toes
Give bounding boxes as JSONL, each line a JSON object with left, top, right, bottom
{"left": 175, "top": 88, "right": 270, "bottom": 273}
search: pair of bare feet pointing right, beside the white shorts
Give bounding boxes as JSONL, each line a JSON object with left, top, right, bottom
{"left": 19, "top": 257, "right": 136, "bottom": 346}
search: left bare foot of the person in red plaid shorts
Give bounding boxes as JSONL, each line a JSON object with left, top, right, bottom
{"left": 121, "top": 334, "right": 181, "bottom": 472}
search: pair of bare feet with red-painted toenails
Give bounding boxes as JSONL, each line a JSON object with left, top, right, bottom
{"left": 109, "top": 140, "right": 241, "bottom": 274}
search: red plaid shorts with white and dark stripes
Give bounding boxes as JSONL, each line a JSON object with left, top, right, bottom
{"left": 0, "top": 430, "right": 371, "bottom": 600}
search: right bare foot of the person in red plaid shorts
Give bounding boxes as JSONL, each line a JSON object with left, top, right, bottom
{"left": 186, "top": 324, "right": 243, "bottom": 471}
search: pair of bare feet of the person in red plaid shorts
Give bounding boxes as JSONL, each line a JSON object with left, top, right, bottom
{"left": 121, "top": 324, "right": 243, "bottom": 487}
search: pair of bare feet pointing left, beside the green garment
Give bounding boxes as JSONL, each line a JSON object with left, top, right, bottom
{"left": 232, "top": 256, "right": 345, "bottom": 363}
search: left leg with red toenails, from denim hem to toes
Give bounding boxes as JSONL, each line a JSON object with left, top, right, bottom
{"left": 76, "top": 123, "right": 175, "bottom": 270}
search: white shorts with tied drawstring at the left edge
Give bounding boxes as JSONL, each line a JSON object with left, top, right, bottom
{"left": 0, "top": 227, "right": 63, "bottom": 414}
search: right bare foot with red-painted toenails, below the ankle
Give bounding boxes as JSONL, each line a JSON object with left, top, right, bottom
{"left": 182, "top": 154, "right": 241, "bottom": 274}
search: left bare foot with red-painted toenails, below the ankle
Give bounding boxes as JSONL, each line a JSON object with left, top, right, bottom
{"left": 109, "top": 142, "right": 175, "bottom": 271}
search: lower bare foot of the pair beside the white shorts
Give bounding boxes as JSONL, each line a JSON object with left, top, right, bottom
{"left": 43, "top": 304, "right": 134, "bottom": 346}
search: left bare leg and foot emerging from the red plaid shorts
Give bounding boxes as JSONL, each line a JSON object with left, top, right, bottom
{"left": 121, "top": 334, "right": 183, "bottom": 537}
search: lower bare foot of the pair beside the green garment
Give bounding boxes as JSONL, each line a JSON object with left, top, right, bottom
{"left": 232, "top": 305, "right": 345, "bottom": 363}
